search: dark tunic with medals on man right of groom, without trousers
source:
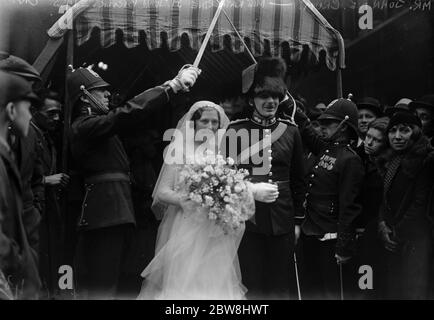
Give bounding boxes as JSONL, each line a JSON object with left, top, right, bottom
{"left": 303, "top": 142, "right": 364, "bottom": 256}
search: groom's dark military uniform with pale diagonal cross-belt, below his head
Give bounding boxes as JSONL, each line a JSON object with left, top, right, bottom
{"left": 227, "top": 115, "right": 305, "bottom": 298}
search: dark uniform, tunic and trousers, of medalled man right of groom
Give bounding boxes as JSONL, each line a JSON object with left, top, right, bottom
{"left": 297, "top": 111, "right": 364, "bottom": 299}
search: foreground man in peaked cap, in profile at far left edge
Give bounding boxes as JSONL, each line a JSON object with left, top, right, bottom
{"left": 0, "top": 71, "right": 40, "bottom": 299}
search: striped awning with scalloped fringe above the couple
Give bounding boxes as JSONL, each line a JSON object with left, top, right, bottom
{"left": 48, "top": 0, "right": 345, "bottom": 70}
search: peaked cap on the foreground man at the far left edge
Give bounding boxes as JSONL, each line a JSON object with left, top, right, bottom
{"left": 0, "top": 71, "right": 40, "bottom": 108}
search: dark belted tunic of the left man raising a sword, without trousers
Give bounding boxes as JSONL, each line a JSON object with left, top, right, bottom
{"left": 71, "top": 87, "right": 169, "bottom": 230}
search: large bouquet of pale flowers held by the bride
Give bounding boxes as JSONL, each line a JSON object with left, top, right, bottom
{"left": 178, "top": 153, "right": 254, "bottom": 234}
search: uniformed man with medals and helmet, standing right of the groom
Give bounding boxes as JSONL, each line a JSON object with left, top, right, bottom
{"left": 296, "top": 99, "right": 364, "bottom": 299}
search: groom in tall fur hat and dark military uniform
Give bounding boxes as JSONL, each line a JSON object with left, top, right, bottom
{"left": 226, "top": 58, "right": 305, "bottom": 299}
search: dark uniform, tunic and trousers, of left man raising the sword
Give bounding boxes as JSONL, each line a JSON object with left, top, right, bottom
{"left": 71, "top": 87, "right": 171, "bottom": 299}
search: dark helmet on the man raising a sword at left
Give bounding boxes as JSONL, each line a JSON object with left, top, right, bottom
{"left": 67, "top": 67, "right": 110, "bottom": 103}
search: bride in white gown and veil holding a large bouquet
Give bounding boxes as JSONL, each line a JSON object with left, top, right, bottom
{"left": 138, "top": 101, "right": 278, "bottom": 300}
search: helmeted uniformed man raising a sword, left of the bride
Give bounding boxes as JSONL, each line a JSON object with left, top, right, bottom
{"left": 67, "top": 63, "right": 200, "bottom": 299}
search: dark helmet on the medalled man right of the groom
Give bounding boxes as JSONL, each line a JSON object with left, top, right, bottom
{"left": 318, "top": 98, "right": 359, "bottom": 137}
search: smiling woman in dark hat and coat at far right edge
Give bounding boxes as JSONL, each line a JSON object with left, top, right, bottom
{"left": 374, "top": 112, "right": 434, "bottom": 299}
